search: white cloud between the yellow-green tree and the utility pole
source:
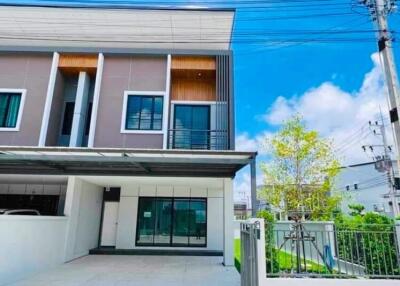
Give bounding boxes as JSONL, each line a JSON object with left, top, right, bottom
{"left": 262, "top": 53, "right": 391, "bottom": 164}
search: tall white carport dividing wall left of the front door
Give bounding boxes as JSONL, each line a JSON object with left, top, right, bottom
{"left": 64, "top": 176, "right": 103, "bottom": 261}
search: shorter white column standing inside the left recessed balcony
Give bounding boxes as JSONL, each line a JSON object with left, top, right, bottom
{"left": 69, "top": 72, "right": 90, "bottom": 147}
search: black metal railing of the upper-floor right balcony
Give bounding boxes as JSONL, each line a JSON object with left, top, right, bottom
{"left": 168, "top": 129, "right": 228, "bottom": 150}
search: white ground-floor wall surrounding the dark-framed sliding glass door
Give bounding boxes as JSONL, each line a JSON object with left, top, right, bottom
{"left": 116, "top": 178, "right": 224, "bottom": 251}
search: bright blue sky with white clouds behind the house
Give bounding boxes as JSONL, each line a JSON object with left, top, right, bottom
{"left": 0, "top": 0, "right": 400, "bottom": 201}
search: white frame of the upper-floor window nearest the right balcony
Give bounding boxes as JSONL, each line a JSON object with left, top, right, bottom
{"left": 121, "top": 90, "right": 168, "bottom": 134}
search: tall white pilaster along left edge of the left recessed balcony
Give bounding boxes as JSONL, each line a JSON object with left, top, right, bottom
{"left": 38, "top": 52, "right": 60, "bottom": 147}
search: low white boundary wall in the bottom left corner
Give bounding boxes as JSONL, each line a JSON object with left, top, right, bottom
{"left": 0, "top": 216, "right": 67, "bottom": 285}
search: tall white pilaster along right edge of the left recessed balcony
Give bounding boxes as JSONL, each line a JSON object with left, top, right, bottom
{"left": 88, "top": 53, "right": 104, "bottom": 148}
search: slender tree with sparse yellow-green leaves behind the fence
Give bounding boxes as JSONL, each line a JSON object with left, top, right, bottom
{"left": 259, "top": 115, "right": 340, "bottom": 219}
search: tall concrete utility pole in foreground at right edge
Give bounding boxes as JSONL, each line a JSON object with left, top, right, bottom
{"left": 361, "top": 0, "right": 400, "bottom": 215}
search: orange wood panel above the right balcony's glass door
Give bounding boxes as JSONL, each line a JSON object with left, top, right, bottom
{"left": 171, "top": 56, "right": 216, "bottom": 70}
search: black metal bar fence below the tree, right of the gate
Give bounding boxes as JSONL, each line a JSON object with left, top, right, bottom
{"left": 265, "top": 223, "right": 400, "bottom": 279}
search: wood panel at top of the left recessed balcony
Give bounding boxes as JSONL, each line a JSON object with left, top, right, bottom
{"left": 58, "top": 54, "right": 98, "bottom": 75}
